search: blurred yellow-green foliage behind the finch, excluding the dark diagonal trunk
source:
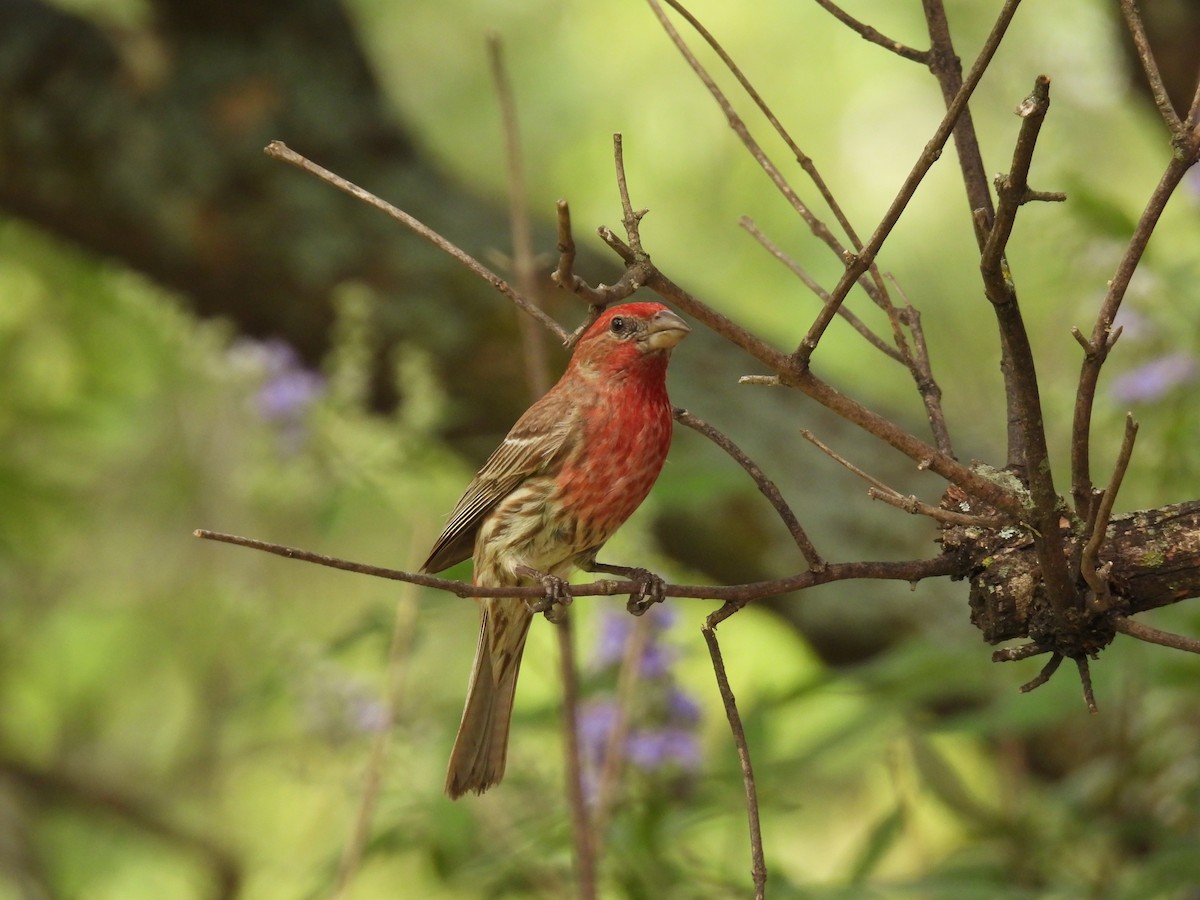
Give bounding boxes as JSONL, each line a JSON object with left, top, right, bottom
{"left": 7, "top": 0, "right": 1200, "bottom": 900}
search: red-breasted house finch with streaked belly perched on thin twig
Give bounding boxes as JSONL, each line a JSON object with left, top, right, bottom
{"left": 422, "top": 302, "right": 690, "bottom": 798}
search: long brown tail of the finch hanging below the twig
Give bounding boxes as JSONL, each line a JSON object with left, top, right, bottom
{"left": 446, "top": 598, "right": 533, "bottom": 799}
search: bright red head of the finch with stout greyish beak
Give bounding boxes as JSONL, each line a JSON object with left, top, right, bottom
{"left": 571, "top": 302, "right": 691, "bottom": 370}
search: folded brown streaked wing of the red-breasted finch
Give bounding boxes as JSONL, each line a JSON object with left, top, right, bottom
{"left": 421, "top": 395, "right": 578, "bottom": 572}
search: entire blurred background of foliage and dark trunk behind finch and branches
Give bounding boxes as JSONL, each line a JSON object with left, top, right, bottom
{"left": 0, "top": 0, "right": 1200, "bottom": 900}
